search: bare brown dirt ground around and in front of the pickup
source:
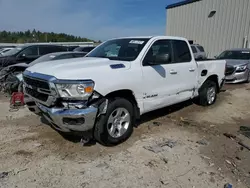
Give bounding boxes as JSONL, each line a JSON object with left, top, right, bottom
{"left": 0, "top": 84, "right": 250, "bottom": 188}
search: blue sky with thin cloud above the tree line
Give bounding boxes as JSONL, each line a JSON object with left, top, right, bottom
{"left": 0, "top": 0, "right": 180, "bottom": 40}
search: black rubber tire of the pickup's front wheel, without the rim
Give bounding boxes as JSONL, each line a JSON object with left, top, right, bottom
{"left": 93, "top": 97, "right": 135, "bottom": 146}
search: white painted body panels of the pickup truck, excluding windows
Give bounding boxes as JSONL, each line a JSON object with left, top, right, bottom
{"left": 27, "top": 36, "right": 226, "bottom": 114}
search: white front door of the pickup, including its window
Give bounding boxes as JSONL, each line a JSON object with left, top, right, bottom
{"left": 142, "top": 39, "right": 180, "bottom": 112}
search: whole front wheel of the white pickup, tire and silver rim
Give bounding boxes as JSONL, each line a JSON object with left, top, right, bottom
{"left": 94, "top": 98, "right": 134, "bottom": 145}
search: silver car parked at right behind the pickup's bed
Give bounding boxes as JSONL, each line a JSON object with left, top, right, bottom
{"left": 217, "top": 48, "right": 250, "bottom": 83}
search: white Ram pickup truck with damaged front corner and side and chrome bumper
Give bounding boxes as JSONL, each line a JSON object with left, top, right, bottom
{"left": 23, "top": 36, "right": 226, "bottom": 145}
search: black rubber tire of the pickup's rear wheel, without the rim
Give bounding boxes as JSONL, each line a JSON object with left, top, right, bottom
{"left": 198, "top": 80, "right": 218, "bottom": 106}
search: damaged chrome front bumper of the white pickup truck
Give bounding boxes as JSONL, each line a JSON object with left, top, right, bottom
{"left": 36, "top": 103, "right": 98, "bottom": 132}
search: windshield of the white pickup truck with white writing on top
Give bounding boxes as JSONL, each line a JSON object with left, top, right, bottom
{"left": 87, "top": 38, "right": 149, "bottom": 61}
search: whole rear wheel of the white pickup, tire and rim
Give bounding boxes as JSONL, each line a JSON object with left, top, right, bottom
{"left": 199, "top": 80, "right": 218, "bottom": 106}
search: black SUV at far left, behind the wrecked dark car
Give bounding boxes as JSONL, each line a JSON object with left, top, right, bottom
{"left": 0, "top": 44, "right": 67, "bottom": 69}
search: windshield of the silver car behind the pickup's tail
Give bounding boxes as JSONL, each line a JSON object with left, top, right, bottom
{"left": 218, "top": 50, "right": 250, "bottom": 60}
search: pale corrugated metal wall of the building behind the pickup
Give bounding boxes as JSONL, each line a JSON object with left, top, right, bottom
{"left": 166, "top": 0, "right": 250, "bottom": 57}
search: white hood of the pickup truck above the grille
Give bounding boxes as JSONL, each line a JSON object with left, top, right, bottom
{"left": 26, "top": 57, "right": 130, "bottom": 80}
